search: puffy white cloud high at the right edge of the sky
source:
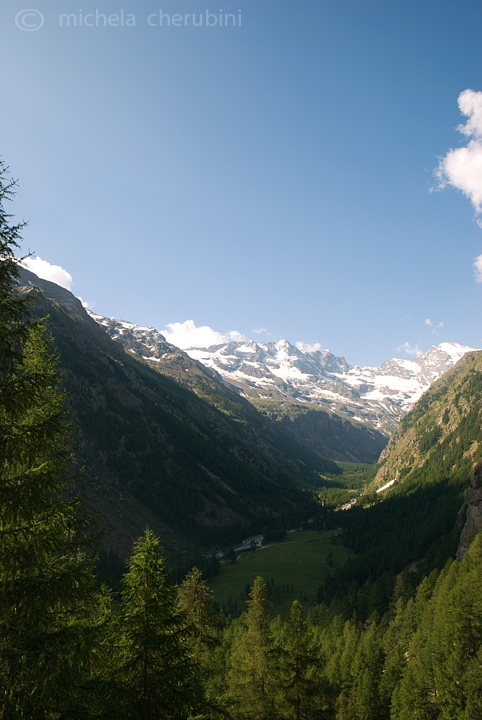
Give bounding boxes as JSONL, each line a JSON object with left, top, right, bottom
{"left": 435, "top": 90, "right": 482, "bottom": 217}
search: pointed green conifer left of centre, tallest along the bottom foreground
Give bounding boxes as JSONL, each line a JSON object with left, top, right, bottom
{"left": 111, "top": 530, "right": 200, "bottom": 720}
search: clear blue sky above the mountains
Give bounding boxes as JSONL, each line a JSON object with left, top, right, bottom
{"left": 0, "top": 0, "right": 482, "bottom": 365}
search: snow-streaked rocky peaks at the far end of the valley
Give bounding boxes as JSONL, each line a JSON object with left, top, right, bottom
{"left": 86, "top": 313, "right": 473, "bottom": 433}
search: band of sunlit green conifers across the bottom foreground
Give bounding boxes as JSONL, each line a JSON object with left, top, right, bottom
{"left": 4, "top": 531, "right": 482, "bottom": 720}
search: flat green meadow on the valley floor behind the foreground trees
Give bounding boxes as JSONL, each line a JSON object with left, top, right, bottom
{"left": 209, "top": 530, "right": 350, "bottom": 617}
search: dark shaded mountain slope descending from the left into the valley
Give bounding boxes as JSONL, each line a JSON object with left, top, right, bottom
{"left": 16, "top": 270, "right": 346, "bottom": 553}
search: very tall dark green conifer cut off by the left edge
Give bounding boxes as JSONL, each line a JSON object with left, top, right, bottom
{"left": 0, "top": 164, "right": 104, "bottom": 720}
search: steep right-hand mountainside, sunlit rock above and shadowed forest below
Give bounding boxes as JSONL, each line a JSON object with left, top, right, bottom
{"left": 332, "top": 352, "right": 482, "bottom": 592}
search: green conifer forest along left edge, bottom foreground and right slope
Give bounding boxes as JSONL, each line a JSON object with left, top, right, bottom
{"left": 0, "top": 163, "right": 482, "bottom": 720}
